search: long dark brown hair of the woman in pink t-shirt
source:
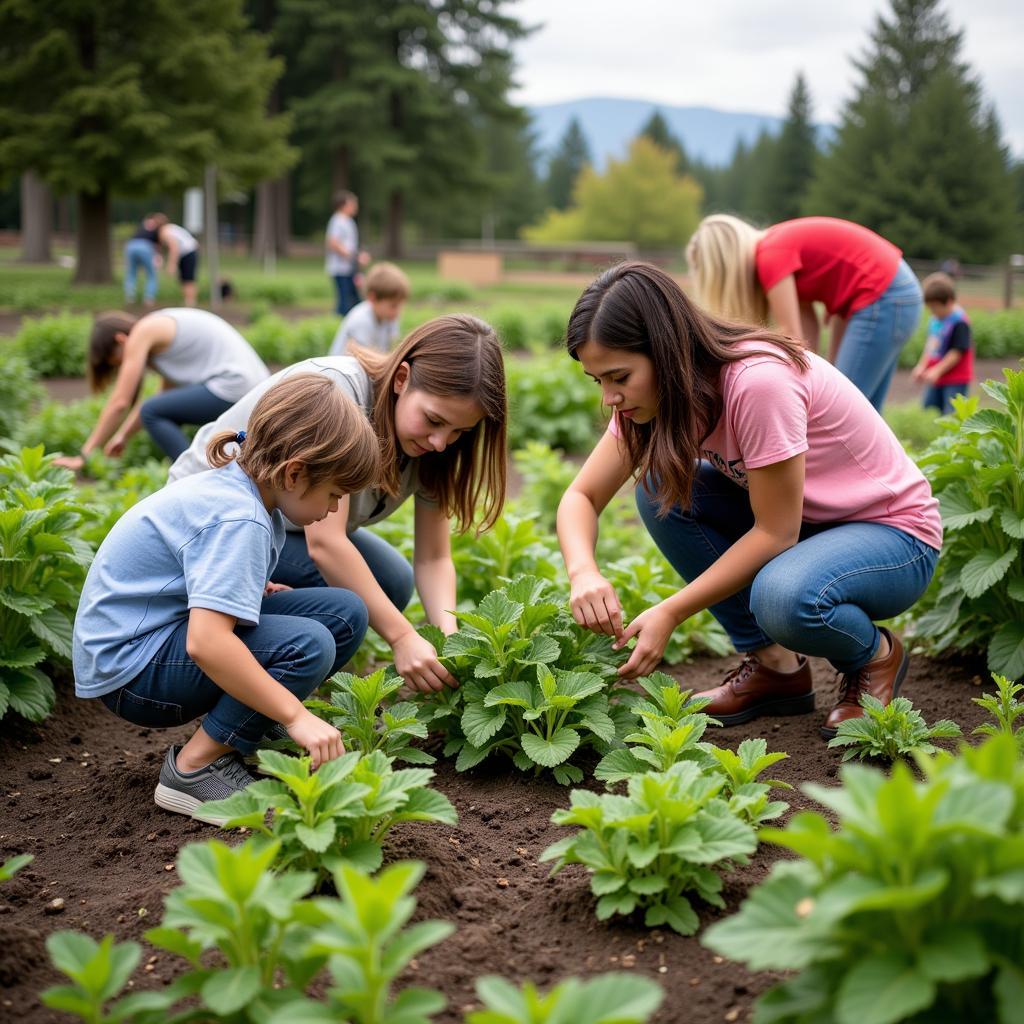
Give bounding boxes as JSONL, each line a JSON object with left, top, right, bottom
{"left": 566, "top": 261, "right": 808, "bottom": 515}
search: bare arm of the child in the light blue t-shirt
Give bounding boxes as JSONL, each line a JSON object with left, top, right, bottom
{"left": 185, "top": 608, "right": 345, "bottom": 768}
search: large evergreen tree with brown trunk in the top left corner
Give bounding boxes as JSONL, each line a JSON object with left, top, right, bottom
{"left": 0, "top": 0, "right": 292, "bottom": 282}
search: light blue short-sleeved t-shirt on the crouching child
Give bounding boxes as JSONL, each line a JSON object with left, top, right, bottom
{"left": 72, "top": 462, "right": 285, "bottom": 697}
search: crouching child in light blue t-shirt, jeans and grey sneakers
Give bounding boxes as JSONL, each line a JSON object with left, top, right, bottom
{"left": 73, "top": 374, "right": 381, "bottom": 814}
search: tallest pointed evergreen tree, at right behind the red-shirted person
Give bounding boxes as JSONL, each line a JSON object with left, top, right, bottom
{"left": 804, "top": 0, "right": 1014, "bottom": 262}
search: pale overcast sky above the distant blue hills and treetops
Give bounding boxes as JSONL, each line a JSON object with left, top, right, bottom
{"left": 512, "top": 0, "right": 1024, "bottom": 157}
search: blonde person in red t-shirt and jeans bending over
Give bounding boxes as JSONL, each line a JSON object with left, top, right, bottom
{"left": 686, "top": 214, "right": 924, "bottom": 411}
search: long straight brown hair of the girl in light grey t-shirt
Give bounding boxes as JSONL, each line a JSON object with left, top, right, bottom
{"left": 349, "top": 313, "right": 508, "bottom": 530}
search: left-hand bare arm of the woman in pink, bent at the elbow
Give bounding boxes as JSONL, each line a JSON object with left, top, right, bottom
{"left": 556, "top": 432, "right": 632, "bottom": 636}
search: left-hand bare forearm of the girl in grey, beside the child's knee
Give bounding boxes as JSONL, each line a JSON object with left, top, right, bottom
{"left": 305, "top": 495, "right": 456, "bottom": 690}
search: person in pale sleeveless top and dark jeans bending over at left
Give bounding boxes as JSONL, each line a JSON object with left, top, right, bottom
{"left": 56, "top": 309, "right": 270, "bottom": 470}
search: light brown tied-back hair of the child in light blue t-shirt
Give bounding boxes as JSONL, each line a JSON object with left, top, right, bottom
{"left": 206, "top": 374, "right": 381, "bottom": 495}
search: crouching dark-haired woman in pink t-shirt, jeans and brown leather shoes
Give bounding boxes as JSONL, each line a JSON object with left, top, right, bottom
{"left": 558, "top": 263, "right": 942, "bottom": 736}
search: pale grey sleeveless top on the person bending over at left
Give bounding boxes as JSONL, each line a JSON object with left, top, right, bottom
{"left": 150, "top": 308, "right": 270, "bottom": 401}
